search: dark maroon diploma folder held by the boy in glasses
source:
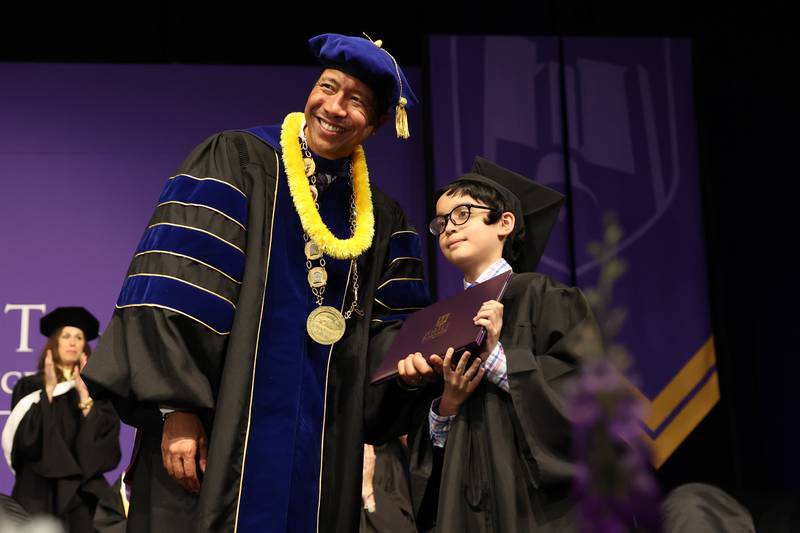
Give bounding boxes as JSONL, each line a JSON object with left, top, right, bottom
{"left": 370, "top": 271, "right": 513, "bottom": 384}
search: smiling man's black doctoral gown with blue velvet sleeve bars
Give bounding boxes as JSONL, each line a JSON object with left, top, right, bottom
{"left": 85, "top": 124, "right": 428, "bottom": 533}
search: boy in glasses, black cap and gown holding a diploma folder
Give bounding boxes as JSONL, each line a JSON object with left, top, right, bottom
{"left": 398, "top": 158, "right": 600, "bottom": 533}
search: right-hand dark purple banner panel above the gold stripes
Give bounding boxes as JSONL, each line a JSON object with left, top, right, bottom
{"left": 564, "top": 39, "right": 711, "bottom": 398}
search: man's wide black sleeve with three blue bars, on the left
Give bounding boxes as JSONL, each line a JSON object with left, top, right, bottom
{"left": 83, "top": 132, "right": 256, "bottom": 427}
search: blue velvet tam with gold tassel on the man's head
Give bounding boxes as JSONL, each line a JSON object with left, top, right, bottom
{"left": 308, "top": 33, "right": 419, "bottom": 139}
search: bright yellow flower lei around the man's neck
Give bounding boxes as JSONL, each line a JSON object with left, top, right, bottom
{"left": 281, "top": 113, "right": 375, "bottom": 259}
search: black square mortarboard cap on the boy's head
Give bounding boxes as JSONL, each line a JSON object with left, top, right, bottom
{"left": 458, "top": 156, "right": 564, "bottom": 272}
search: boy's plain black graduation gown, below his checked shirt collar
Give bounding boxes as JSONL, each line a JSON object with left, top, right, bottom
{"left": 411, "top": 273, "right": 600, "bottom": 533}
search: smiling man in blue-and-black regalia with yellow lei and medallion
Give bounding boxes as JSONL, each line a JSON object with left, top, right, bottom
{"left": 85, "top": 34, "right": 428, "bottom": 533}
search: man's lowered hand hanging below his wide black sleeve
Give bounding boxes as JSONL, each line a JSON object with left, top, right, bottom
{"left": 161, "top": 411, "right": 208, "bottom": 492}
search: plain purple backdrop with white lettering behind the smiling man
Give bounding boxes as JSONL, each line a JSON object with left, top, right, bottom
{"left": 0, "top": 64, "right": 427, "bottom": 493}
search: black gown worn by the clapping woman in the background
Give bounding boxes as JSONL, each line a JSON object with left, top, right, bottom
{"left": 11, "top": 374, "right": 121, "bottom": 533}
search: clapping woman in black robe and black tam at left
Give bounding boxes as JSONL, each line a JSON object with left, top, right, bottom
{"left": 3, "top": 307, "right": 121, "bottom": 533}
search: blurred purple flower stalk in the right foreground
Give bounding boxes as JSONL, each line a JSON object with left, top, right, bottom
{"left": 570, "top": 216, "right": 661, "bottom": 533}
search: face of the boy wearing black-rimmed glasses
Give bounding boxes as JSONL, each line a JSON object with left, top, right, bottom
{"left": 436, "top": 193, "right": 514, "bottom": 272}
